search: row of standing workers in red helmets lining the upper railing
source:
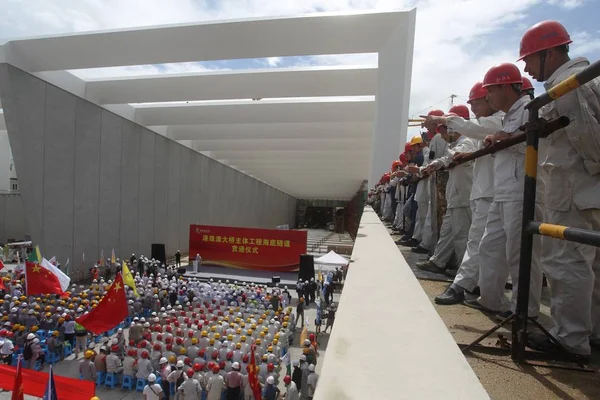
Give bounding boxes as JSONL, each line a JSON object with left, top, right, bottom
{"left": 368, "top": 21, "right": 600, "bottom": 363}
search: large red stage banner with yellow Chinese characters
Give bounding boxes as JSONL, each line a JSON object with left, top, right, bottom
{"left": 189, "top": 225, "right": 307, "bottom": 272}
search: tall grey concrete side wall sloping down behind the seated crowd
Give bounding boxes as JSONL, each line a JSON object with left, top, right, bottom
{"left": 0, "top": 63, "right": 296, "bottom": 278}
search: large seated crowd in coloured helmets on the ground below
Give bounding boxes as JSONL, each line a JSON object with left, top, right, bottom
{"left": 0, "top": 272, "right": 321, "bottom": 400}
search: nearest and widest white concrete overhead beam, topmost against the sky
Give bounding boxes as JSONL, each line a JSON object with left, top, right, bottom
{"left": 5, "top": 11, "right": 411, "bottom": 72}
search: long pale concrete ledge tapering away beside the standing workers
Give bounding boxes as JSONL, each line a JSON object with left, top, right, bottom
{"left": 314, "top": 207, "right": 489, "bottom": 400}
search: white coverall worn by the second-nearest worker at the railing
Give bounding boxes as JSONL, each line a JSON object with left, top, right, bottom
{"left": 479, "top": 97, "right": 542, "bottom": 317}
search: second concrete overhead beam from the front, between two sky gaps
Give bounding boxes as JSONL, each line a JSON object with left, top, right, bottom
{"left": 87, "top": 67, "right": 377, "bottom": 104}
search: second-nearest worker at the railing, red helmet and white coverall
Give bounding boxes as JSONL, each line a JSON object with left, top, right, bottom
{"left": 464, "top": 63, "right": 542, "bottom": 317}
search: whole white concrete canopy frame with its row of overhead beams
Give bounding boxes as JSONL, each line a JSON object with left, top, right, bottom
{"left": 0, "top": 9, "right": 416, "bottom": 199}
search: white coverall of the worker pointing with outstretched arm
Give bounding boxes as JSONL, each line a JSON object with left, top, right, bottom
{"left": 446, "top": 111, "right": 504, "bottom": 291}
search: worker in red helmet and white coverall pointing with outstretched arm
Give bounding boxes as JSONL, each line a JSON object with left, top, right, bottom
{"left": 426, "top": 82, "right": 504, "bottom": 305}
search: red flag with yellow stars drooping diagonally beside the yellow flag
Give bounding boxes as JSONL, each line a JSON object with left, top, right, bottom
{"left": 76, "top": 273, "right": 129, "bottom": 335}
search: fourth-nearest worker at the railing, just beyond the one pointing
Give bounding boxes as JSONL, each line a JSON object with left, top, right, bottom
{"left": 417, "top": 106, "right": 477, "bottom": 273}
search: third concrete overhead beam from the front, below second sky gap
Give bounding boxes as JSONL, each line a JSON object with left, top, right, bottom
{"left": 136, "top": 100, "right": 375, "bottom": 125}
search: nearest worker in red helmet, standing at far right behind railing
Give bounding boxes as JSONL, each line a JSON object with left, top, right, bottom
{"left": 520, "top": 21, "right": 600, "bottom": 361}
